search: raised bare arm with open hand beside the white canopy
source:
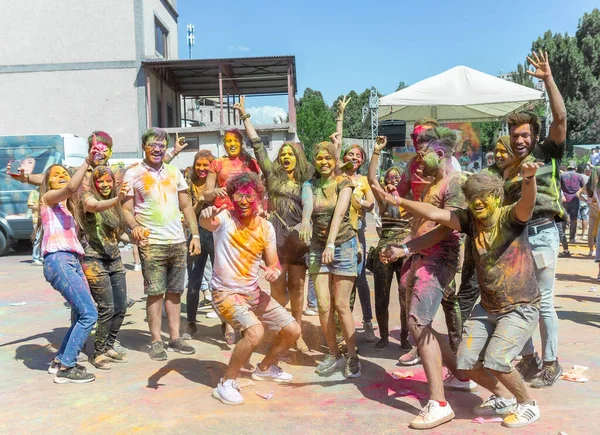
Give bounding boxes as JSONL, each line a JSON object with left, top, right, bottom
{"left": 527, "top": 51, "right": 567, "bottom": 144}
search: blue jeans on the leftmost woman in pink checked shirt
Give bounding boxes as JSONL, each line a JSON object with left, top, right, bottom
{"left": 44, "top": 251, "right": 98, "bottom": 367}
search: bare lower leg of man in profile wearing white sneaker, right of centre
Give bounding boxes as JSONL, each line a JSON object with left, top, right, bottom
{"left": 408, "top": 317, "right": 446, "bottom": 402}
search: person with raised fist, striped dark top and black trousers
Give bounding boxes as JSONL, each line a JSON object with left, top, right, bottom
{"left": 368, "top": 136, "right": 412, "bottom": 351}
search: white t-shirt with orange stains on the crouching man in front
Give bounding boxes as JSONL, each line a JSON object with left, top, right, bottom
{"left": 210, "top": 210, "right": 277, "bottom": 293}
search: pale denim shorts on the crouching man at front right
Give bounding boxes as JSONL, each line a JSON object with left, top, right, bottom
{"left": 456, "top": 304, "right": 539, "bottom": 373}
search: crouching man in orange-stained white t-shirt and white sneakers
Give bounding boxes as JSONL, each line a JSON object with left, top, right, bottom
{"left": 200, "top": 173, "right": 300, "bottom": 405}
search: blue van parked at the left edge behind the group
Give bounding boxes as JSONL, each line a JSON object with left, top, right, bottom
{"left": 0, "top": 134, "right": 88, "bottom": 255}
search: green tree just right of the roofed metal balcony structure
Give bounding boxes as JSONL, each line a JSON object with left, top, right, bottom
{"left": 296, "top": 88, "right": 335, "bottom": 160}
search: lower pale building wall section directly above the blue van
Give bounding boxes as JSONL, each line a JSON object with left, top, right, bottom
{"left": 0, "top": 68, "right": 141, "bottom": 153}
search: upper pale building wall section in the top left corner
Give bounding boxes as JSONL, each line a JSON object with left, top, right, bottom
{"left": 0, "top": 0, "right": 135, "bottom": 65}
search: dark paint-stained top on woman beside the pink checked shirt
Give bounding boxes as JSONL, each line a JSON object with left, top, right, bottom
{"left": 79, "top": 192, "right": 121, "bottom": 260}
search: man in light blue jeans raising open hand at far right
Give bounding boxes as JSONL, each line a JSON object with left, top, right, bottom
{"left": 505, "top": 53, "right": 567, "bottom": 388}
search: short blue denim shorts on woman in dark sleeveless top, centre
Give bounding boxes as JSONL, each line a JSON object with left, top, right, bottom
{"left": 308, "top": 237, "right": 358, "bottom": 276}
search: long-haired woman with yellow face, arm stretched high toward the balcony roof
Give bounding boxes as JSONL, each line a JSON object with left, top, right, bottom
{"left": 234, "top": 96, "right": 314, "bottom": 352}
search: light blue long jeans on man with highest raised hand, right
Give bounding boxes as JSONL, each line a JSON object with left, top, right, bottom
{"left": 522, "top": 225, "right": 560, "bottom": 362}
